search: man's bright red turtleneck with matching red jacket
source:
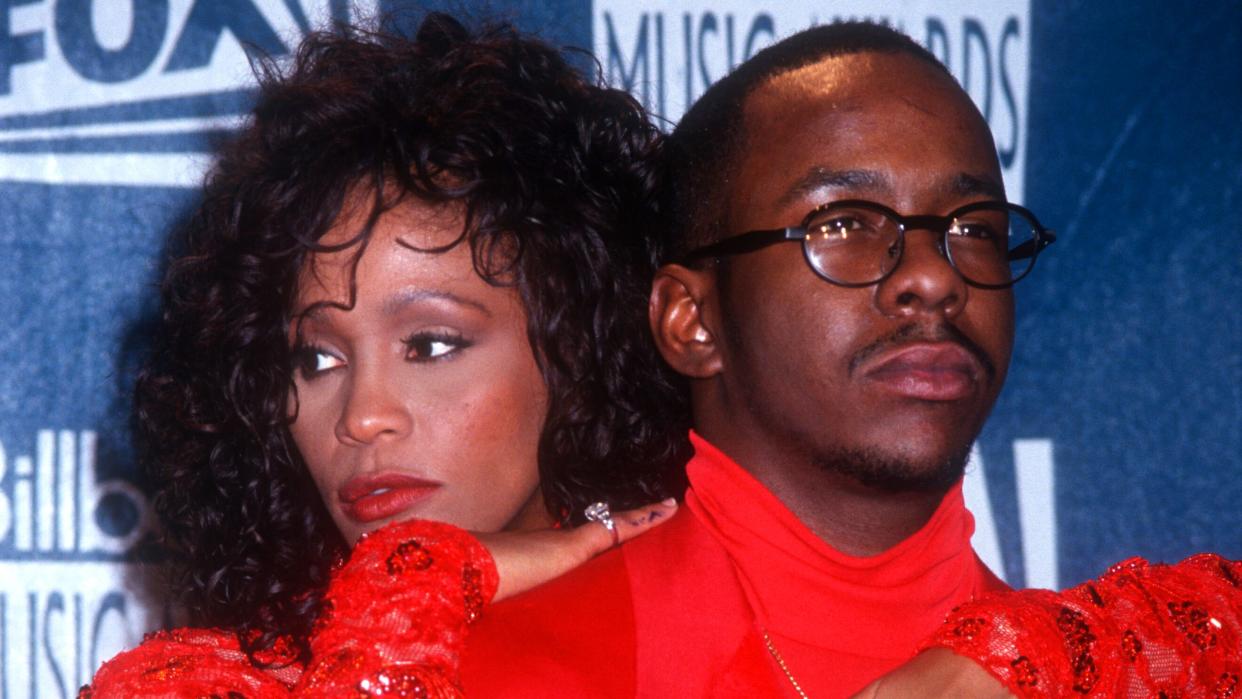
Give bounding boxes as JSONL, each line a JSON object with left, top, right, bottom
{"left": 462, "top": 433, "right": 1004, "bottom": 699}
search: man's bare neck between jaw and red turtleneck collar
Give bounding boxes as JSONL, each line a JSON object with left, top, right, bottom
{"left": 703, "top": 431, "right": 946, "bottom": 556}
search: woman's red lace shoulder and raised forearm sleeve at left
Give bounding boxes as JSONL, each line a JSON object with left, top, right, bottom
{"left": 78, "top": 520, "right": 498, "bottom": 699}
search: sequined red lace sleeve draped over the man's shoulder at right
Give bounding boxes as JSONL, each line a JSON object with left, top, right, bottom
{"left": 925, "top": 554, "right": 1242, "bottom": 698}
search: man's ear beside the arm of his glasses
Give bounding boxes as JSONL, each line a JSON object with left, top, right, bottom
{"left": 647, "top": 264, "right": 723, "bottom": 379}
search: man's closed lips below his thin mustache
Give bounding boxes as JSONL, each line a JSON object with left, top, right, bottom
{"left": 864, "top": 343, "right": 981, "bottom": 401}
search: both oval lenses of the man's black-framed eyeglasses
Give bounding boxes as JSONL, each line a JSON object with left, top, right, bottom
{"left": 802, "top": 204, "right": 1036, "bottom": 286}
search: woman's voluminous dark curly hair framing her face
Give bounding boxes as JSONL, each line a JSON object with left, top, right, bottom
{"left": 135, "top": 14, "right": 689, "bottom": 661}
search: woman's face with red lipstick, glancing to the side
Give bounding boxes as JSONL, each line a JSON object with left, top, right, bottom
{"left": 289, "top": 196, "right": 549, "bottom": 544}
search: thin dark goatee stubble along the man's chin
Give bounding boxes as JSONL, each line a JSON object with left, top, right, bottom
{"left": 814, "top": 444, "right": 970, "bottom": 494}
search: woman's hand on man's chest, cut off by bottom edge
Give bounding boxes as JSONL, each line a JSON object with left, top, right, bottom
{"left": 854, "top": 650, "right": 1013, "bottom": 699}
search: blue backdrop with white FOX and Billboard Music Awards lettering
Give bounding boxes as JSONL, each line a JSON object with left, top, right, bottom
{"left": 0, "top": 0, "right": 1242, "bottom": 697}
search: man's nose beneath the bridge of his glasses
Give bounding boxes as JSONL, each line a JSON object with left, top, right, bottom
{"left": 876, "top": 230, "right": 969, "bottom": 318}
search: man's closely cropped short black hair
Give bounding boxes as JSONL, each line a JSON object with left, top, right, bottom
{"left": 663, "top": 21, "right": 949, "bottom": 261}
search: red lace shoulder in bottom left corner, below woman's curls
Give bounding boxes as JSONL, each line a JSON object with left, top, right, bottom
{"left": 78, "top": 628, "right": 298, "bottom": 699}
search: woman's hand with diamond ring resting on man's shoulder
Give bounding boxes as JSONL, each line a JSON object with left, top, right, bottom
{"left": 474, "top": 498, "right": 677, "bottom": 602}
